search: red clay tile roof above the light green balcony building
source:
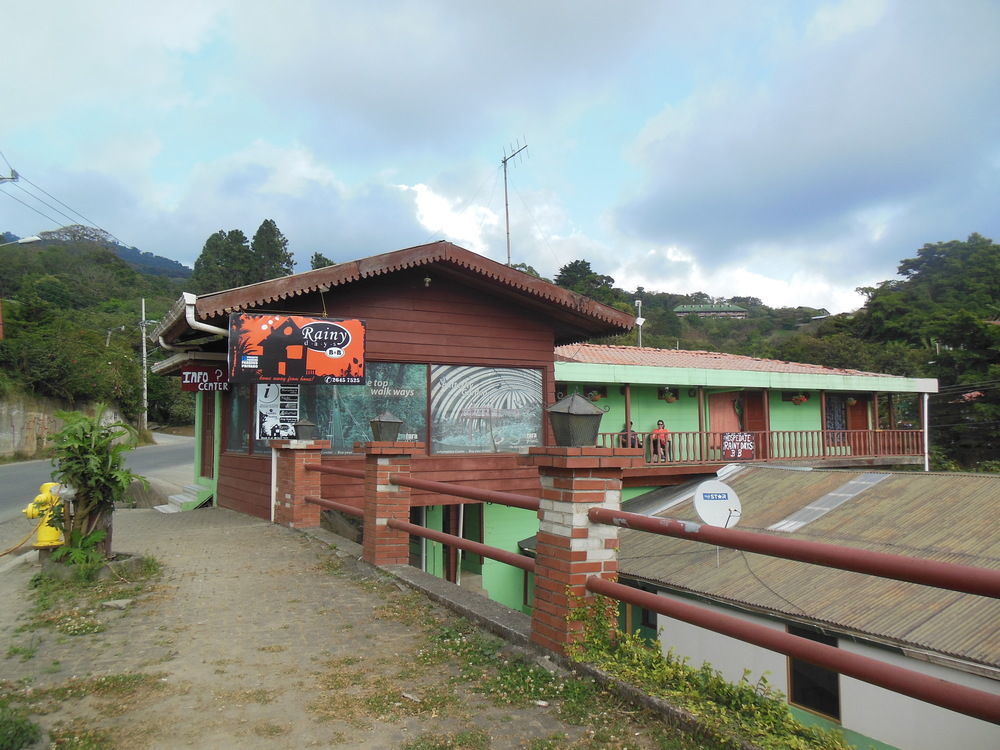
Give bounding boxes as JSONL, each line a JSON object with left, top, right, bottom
{"left": 556, "top": 344, "right": 894, "bottom": 378}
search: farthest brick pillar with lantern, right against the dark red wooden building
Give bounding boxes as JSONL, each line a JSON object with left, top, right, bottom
{"left": 271, "top": 440, "right": 330, "bottom": 529}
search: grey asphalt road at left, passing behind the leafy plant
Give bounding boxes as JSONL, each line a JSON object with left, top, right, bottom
{"left": 0, "top": 433, "right": 194, "bottom": 523}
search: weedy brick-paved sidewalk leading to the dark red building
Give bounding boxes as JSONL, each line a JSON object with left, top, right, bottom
{"left": 0, "top": 509, "right": 616, "bottom": 750}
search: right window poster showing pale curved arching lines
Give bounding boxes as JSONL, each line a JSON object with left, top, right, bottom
{"left": 431, "top": 365, "right": 542, "bottom": 453}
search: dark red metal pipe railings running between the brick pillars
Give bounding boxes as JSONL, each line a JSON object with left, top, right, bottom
{"left": 306, "top": 464, "right": 1000, "bottom": 724}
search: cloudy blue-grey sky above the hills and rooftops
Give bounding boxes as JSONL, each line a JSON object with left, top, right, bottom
{"left": 0, "top": 0, "right": 1000, "bottom": 312}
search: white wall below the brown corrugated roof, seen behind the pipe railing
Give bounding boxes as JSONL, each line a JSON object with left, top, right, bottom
{"left": 657, "top": 593, "right": 1000, "bottom": 750}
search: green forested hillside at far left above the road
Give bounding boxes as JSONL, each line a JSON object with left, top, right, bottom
{"left": 0, "top": 233, "right": 193, "bottom": 423}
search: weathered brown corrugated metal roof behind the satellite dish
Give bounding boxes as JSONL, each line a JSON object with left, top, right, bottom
{"left": 620, "top": 466, "right": 1000, "bottom": 669}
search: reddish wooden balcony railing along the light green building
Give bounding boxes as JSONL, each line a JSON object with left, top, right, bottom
{"left": 597, "top": 430, "right": 924, "bottom": 464}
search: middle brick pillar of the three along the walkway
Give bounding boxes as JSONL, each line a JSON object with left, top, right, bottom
{"left": 354, "top": 441, "right": 423, "bottom": 565}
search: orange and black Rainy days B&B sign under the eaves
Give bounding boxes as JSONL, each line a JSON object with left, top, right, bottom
{"left": 229, "top": 313, "right": 365, "bottom": 385}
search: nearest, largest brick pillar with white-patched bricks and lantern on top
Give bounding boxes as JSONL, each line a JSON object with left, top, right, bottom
{"left": 527, "top": 446, "right": 642, "bottom": 654}
